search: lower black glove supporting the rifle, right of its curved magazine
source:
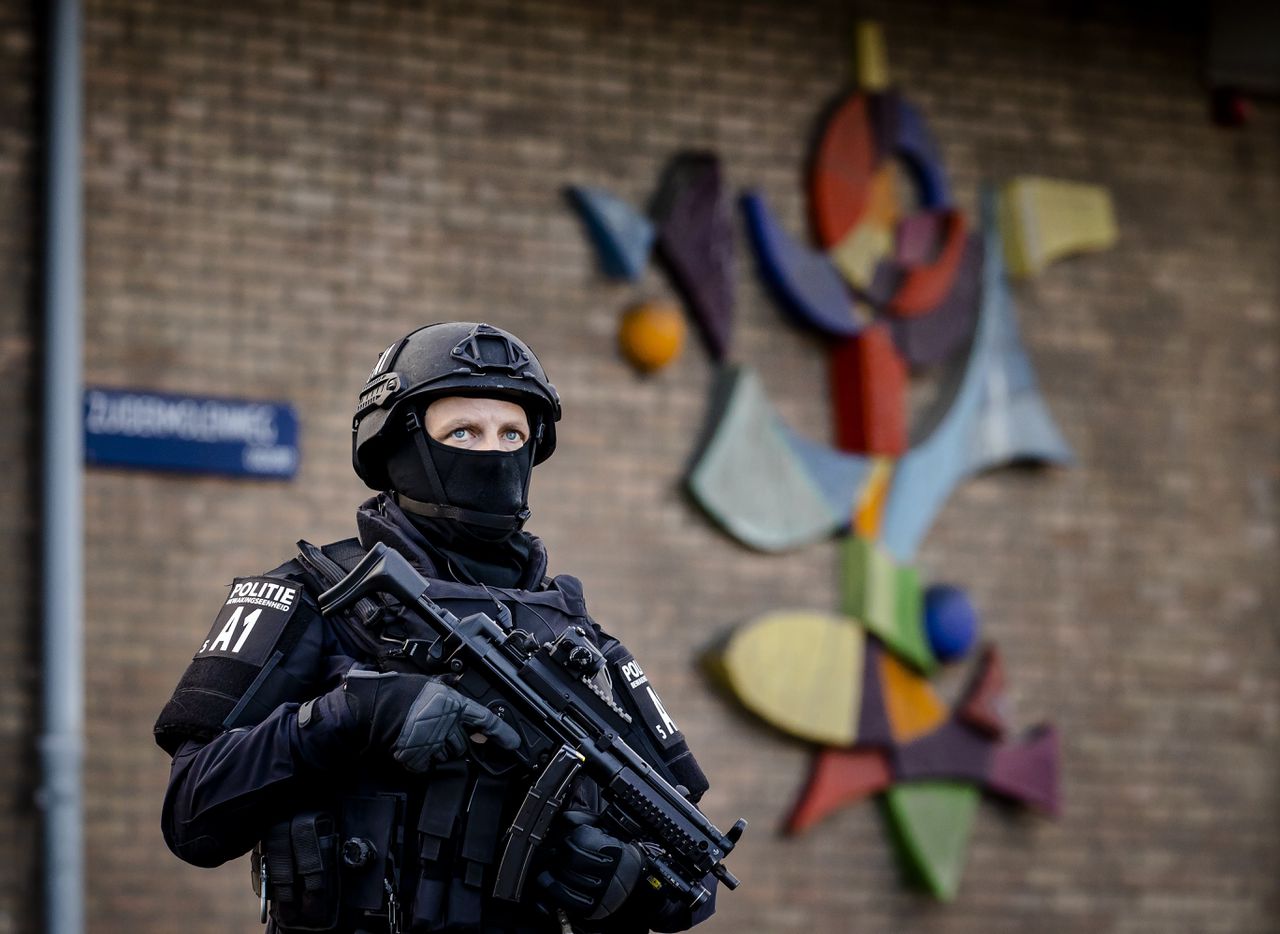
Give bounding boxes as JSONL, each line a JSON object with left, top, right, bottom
{"left": 538, "top": 811, "right": 644, "bottom": 921}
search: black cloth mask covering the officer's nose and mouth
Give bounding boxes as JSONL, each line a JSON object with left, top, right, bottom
{"left": 387, "top": 431, "right": 534, "bottom": 541}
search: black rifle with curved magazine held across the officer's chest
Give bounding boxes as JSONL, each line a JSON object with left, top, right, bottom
{"left": 320, "top": 544, "right": 746, "bottom": 908}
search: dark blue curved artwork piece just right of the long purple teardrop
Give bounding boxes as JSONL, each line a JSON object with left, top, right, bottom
{"left": 741, "top": 192, "right": 861, "bottom": 338}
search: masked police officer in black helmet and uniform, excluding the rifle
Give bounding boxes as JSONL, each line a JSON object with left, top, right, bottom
{"left": 155, "top": 322, "right": 714, "bottom": 934}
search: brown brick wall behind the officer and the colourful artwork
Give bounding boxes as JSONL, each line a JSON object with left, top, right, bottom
{"left": 0, "top": 0, "right": 1280, "bottom": 934}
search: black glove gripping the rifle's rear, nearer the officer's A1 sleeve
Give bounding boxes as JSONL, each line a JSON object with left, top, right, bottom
{"left": 298, "top": 668, "right": 520, "bottom": 772}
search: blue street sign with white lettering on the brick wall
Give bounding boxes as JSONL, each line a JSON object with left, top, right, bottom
{"left": 84, "top": 389, "right": 298, "bottom": 479}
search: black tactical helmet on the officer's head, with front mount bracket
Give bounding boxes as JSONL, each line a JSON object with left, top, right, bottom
{"left": 351, "top": 321, "right": 561, "bottom": 490}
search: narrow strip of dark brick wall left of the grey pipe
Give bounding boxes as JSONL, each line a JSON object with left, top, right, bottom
{"left": 0, "top": 3, "right": 40, "bottom": 934}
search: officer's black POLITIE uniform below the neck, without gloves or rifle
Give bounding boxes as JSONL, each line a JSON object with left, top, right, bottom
{"left": 156, "top": 495, "right": 714, "bottom": 934}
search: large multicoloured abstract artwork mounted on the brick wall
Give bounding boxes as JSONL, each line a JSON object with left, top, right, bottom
{"left": 560, "top": 16, "right": 1116, "bottom": 899}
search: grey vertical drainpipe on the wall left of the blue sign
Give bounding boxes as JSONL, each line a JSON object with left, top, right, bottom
{"left": 40, "top": 0, "right": 84, "bottom": 934}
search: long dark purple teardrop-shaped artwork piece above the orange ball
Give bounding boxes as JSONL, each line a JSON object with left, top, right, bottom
{"left": 650, "top": 152, "right": 733, "bottom": 360}
